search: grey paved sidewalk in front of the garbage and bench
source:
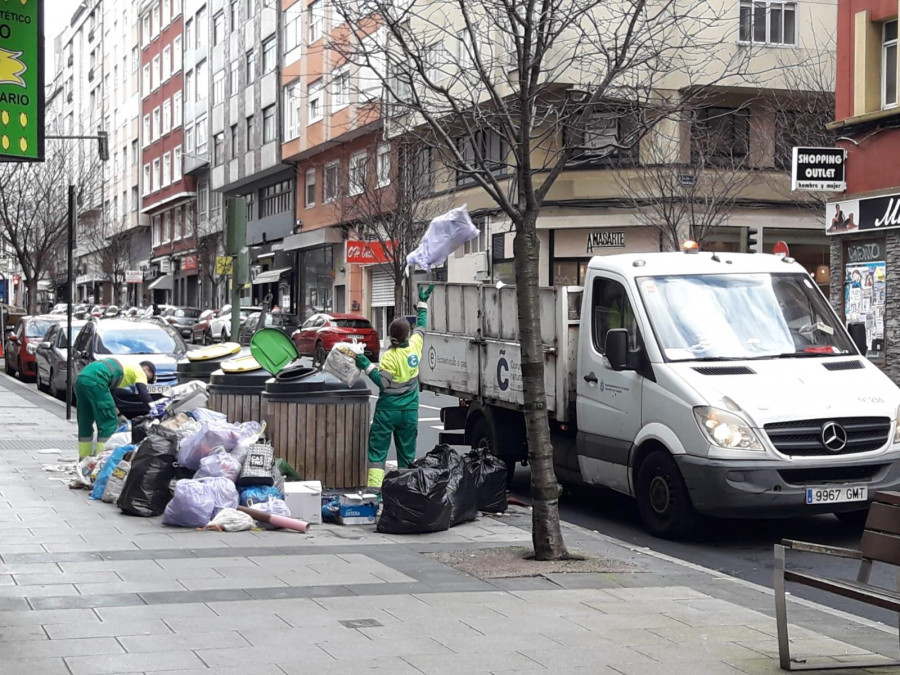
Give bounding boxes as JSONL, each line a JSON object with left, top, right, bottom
{"left": 0, "top": 380, "right": 897, "bottom": 675}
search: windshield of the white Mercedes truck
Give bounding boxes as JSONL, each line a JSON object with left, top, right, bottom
{"left": 637, "top": 274, "right": 854, "bottom": 361}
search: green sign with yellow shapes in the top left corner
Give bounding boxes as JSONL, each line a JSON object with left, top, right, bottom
{"left": 0, "top": 0, "right": 44, "bottom": 161}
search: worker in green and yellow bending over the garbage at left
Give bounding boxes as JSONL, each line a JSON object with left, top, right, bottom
{"left": 75, "top": 359, "right": 156, "bottom": 457}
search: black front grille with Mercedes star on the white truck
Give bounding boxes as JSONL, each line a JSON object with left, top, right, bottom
{"left": 764, "top": 417, "right": 891, "bottom": 457}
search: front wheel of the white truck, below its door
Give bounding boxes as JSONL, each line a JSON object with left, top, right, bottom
{"left": 637, "top": 450, "right": 698, "bottom": 539}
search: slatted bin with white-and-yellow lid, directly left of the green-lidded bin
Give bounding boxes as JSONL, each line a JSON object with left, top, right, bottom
{"left": 206, "top": 356, "right": 271, "bottom": 422}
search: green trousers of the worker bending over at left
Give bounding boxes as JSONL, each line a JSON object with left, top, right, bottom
{"left": 75, "top": 361, "right": 122, "bottom": 457}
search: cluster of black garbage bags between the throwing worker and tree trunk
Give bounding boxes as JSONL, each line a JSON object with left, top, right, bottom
{"left": 377, "top": 445, "right": 507, "bottom": 534}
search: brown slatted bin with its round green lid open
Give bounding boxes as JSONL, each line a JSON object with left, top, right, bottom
{"left": 250, "top": 328, "right": 371, "bottom": 489}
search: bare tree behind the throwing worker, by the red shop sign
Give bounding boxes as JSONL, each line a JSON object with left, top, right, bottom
{"left": 340, "top": 138, "right": 446, "bottom": 314}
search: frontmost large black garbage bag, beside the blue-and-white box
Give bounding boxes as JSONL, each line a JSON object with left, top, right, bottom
{"left": 376, "top": 466, "right": 451, "bottom": 534}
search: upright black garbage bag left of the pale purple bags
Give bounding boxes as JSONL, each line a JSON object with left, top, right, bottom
{"left": 116, "top": 426, "right": 178, "bottom": 518}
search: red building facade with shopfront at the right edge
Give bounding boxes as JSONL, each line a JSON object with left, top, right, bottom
{"left": 823, "top": 0, "right": 900, "bottom": 383}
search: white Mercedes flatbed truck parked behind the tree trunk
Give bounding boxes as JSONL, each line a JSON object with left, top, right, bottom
{"left": 419, "top": 252, "right": 900, "bottom": 538}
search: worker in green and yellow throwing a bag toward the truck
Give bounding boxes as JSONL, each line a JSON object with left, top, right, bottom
{"left": 347, "top": 285, "right": 434, "bottom": 489}
